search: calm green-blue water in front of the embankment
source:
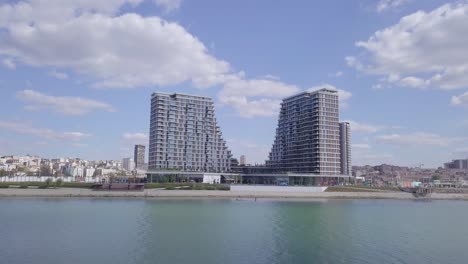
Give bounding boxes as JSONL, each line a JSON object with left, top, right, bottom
{"left": 0, "top": 198, "right": 468, "bottom": 264}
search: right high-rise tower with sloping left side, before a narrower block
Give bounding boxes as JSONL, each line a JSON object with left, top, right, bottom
{"left": 267, "top": 88, "right": 341, "bottom": 176}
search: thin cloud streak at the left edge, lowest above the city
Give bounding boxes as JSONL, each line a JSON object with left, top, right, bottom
{"left": 0, "top": 121, "right": 91, "bottom": 141}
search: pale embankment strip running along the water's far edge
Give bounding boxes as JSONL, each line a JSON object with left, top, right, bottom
{"left": 0, "top": 188, "right": 468, "bottom": 200}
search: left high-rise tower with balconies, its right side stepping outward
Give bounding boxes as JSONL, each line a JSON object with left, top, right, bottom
{"left": 148, "top": 93, "right": 231, "bottom": 172}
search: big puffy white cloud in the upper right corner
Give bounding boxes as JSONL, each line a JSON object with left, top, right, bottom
{"left": 345, "top": 3, "right": 468, "bottom": 89}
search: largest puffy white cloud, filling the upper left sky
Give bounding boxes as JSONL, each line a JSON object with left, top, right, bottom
{"left": 0, "top": 0, "right": 230, "bottom": 88}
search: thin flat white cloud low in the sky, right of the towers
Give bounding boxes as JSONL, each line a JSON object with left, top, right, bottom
{"left": 376, "top": 132, "right": 463, "bottom": 147}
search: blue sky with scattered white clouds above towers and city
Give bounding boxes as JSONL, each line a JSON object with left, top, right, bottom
{"left": 0, "top": 0, "right": 468, "bottom": 168}
